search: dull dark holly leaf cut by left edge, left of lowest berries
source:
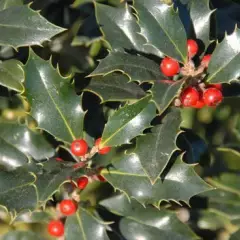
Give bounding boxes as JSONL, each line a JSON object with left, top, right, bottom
{"left": 0, "top": 168, "right": 37, "bottom": 212}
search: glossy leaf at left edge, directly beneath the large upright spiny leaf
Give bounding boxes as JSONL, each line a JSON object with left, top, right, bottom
{"left": 0, "top": 122, "right": 55, "bottom": 160}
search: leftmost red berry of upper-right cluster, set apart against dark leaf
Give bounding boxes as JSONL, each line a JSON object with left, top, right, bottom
{"left": 160, "top": 57, "right": 180, "bottom": 77}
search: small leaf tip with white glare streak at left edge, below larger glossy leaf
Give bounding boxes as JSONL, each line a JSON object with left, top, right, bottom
{"left": 0, "top": 137, "right": 28, "bottom": 169}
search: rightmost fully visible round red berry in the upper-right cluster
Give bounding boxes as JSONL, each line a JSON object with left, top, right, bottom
{"left": 203, "top": 88, "right": 223, "bottom": 107}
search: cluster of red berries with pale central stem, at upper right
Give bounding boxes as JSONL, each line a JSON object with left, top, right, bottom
{"left": 160, "top": 39, "right": 223, "bottom": 108}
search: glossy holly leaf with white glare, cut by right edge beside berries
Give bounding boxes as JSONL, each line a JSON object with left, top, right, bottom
{"left": 207, "top": 29, "right": 240, "bottom": 83}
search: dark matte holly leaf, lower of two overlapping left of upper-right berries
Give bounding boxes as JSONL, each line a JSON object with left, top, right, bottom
{"left": 84, "top": 74, "right": 145, "bottom": 103}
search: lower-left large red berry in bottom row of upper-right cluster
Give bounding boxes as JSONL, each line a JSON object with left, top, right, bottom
{"left": 180, "top": 87, "right": 200, "bottom": 107}
